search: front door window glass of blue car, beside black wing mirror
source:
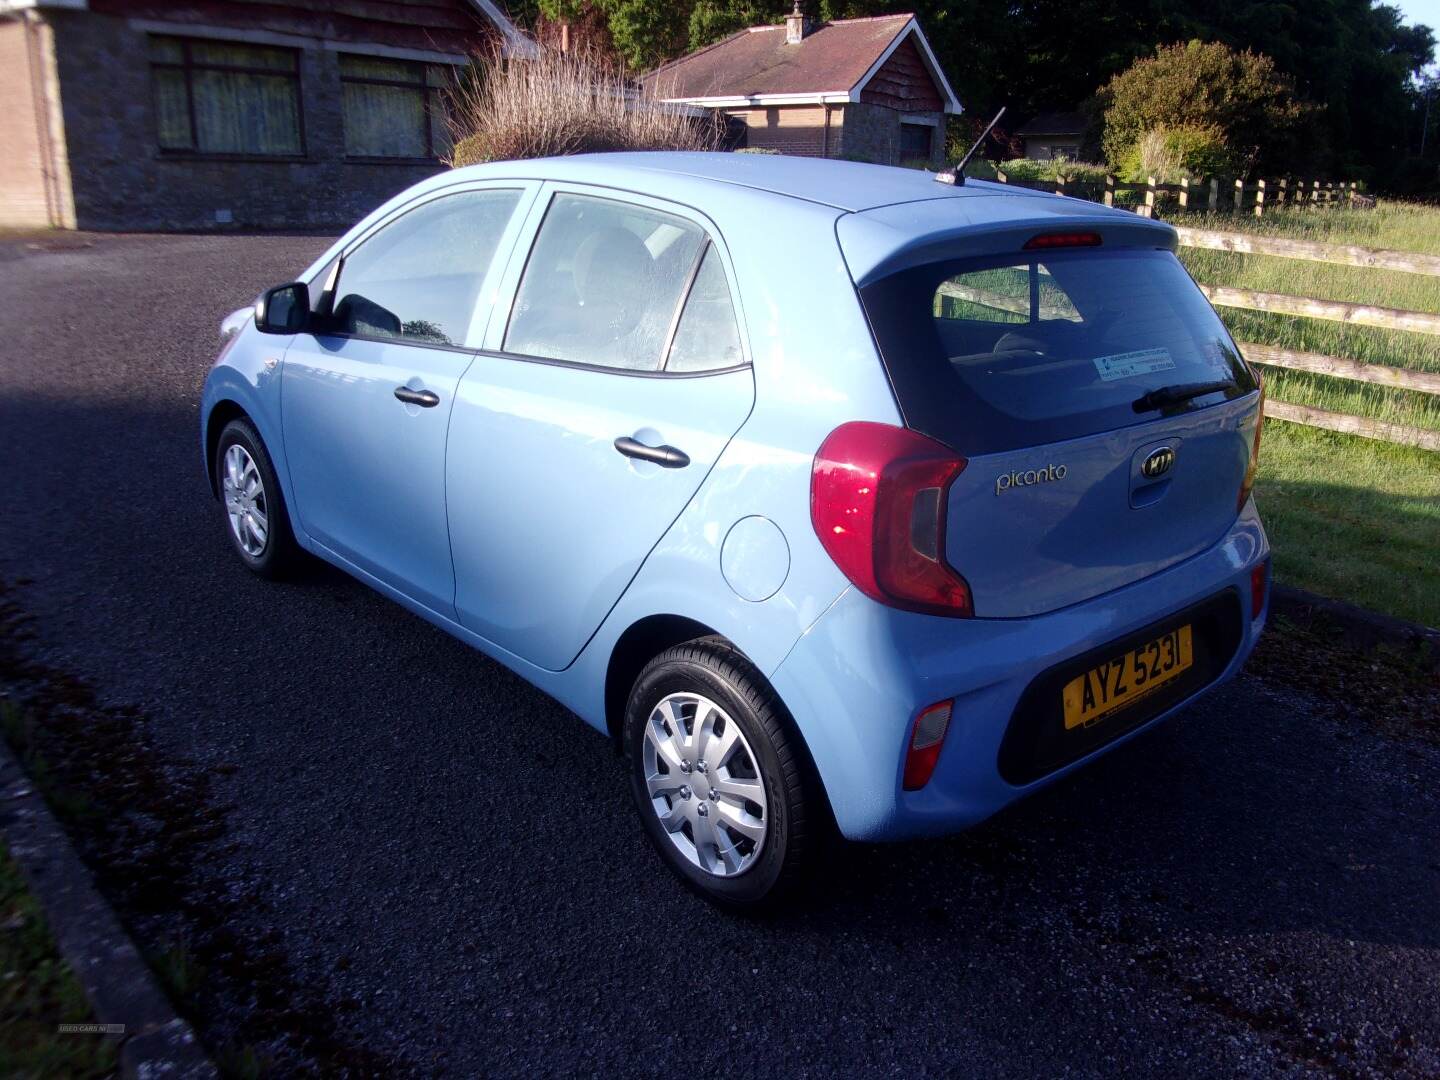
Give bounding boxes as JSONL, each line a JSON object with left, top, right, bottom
{"left": 331, "top": 190, "right": 520, "bottom": 346}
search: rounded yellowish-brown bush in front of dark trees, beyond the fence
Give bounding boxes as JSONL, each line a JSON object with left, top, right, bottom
{"left": 1099, "top": 42, "right": 1315, "bottom": 171}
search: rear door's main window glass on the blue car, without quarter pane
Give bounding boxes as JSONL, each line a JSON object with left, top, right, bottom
{"left": 504, "top": 194, "right": 706, "bottom": 372}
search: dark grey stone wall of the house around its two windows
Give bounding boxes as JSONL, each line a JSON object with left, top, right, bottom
{"left": 48, "top": 12, "right": 441, "bottom": 229}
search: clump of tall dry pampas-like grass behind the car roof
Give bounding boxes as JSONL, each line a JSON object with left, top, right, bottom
{"left": 449, "top": 49, "right": 724, "bottom": 168}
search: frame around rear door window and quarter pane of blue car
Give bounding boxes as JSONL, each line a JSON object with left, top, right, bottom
{"left": 480, "top": 181, "right": 755, "bottom": 379}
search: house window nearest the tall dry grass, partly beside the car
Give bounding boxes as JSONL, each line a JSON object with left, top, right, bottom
{"left": 340, "top": 53, "right": 452, "bottom": 160}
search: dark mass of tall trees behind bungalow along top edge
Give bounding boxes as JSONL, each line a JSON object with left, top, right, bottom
{"left": 510, "top": 0, "right": 1440, "bottom": 186}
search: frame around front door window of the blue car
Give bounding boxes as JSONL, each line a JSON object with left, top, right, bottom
{"left": 310, "top": 179, "right": 539, "bottom": 356}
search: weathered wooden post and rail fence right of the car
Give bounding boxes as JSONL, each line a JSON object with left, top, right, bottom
{"left": 999, "top": 173, "right": 1440, "bottom": 452}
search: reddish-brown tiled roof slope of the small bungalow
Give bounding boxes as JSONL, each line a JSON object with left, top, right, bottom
{"left": 642, "top": 14, "right": 913, "bottom": 99}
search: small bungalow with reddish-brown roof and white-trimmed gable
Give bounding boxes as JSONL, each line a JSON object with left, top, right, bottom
{"left": 642, "top": 3, "right": 960, "bottom": 164}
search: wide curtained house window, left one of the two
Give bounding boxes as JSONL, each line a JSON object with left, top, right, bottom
{"left": 150, "top": 37, "right": 305, "bottom": 157}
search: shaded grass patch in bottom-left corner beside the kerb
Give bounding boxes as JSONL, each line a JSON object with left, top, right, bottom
{"left": 0, "top": 847, "right": 115, "bottom": 1079}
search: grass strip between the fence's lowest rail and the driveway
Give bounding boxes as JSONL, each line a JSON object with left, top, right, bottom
{"left": 1256, "top": 420, "right": 1440, "bottom": 626}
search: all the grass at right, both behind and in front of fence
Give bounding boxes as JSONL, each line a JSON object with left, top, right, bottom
{"left": 1181, "top": 202, "right": 1440, "bottom": 626}
